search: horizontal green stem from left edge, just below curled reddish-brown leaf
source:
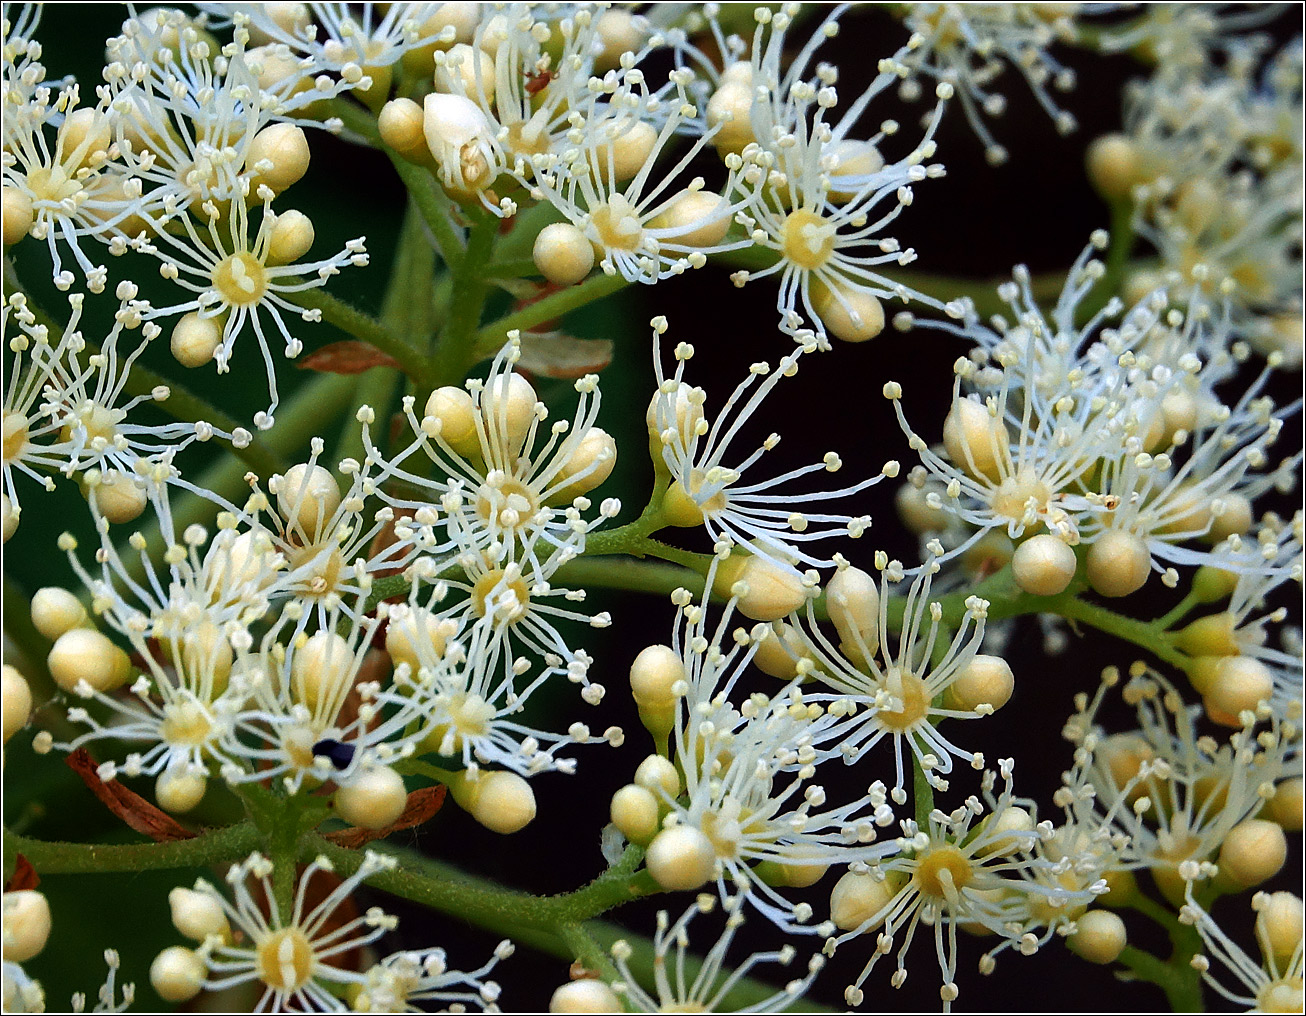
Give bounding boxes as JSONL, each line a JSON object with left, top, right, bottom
{"left": 4, "top": 821, "right": 261, "bottom": 878}
